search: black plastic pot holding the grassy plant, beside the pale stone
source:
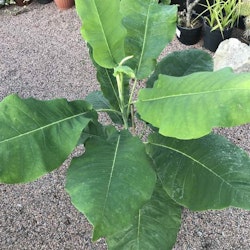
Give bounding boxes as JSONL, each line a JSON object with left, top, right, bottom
{"left": 203, "top": 22, "right": 233, "bottom": 52}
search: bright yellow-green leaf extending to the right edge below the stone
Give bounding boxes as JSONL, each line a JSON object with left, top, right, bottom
{"left": 136, "top": 68, "right": 250, "bottom": 139}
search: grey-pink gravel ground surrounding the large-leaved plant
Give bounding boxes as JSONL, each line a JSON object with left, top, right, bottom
{"left": 0, "top": 2, "right": 250, "bottom": 250}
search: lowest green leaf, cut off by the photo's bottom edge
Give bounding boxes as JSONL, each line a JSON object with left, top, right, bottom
{"left": 107, "top": 184, "right": 181, "bottom": 250}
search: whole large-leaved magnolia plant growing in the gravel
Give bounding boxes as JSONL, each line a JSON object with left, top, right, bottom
{"left": 0, "top": 0, "right": 250, "bottom": 250}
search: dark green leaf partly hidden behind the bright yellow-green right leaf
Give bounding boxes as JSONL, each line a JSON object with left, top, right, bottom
{"left": 147, "top": 49, "right": 213, "bottom": 88}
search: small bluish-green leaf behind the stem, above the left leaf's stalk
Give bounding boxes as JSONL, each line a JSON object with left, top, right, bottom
{"left": 85, "top": 91, "right": 123, "bottom": 124}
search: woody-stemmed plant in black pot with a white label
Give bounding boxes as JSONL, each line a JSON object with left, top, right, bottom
{"left": 176, "top": 0, "right": 203, "bottom": 45}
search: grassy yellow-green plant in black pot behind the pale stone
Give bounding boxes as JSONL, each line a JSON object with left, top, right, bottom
{"left": 200, "top": 0, "right": 241, "bottom": 52}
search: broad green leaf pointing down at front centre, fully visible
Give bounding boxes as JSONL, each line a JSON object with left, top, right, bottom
{"left": 66, "top": 128, "right": 155, "bottom": 240}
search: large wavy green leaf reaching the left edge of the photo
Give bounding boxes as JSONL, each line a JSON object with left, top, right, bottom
{"left": 0, "top": 95, "right": 96, "bottom": 183}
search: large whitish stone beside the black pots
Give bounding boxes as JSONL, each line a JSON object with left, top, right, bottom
{"left": 214, "top": 38, "right": 250, "bottom": 73}
